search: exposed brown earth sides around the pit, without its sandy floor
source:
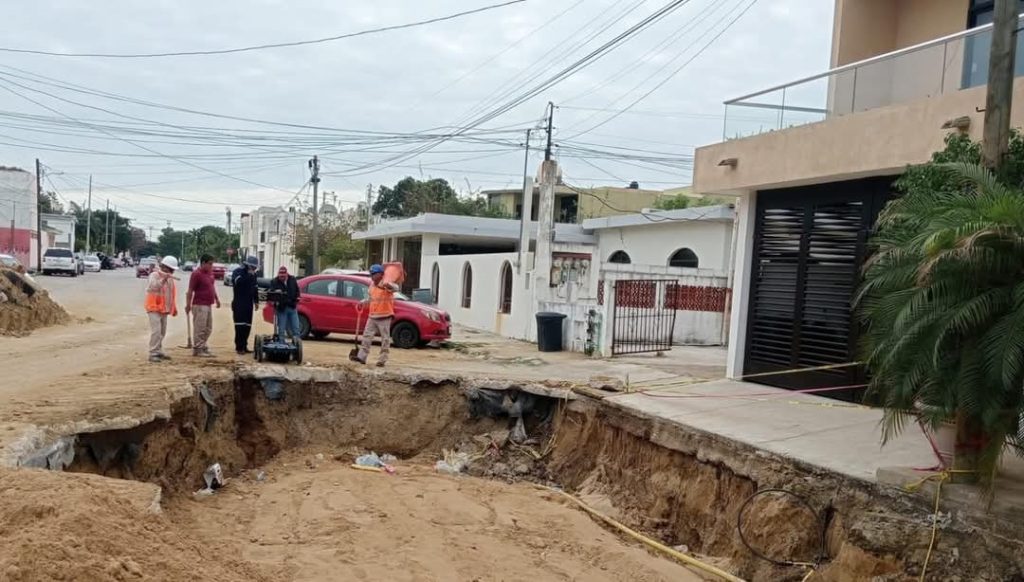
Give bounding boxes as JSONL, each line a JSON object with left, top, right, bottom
{"left": 12, "top": 369, "right": 1024, "bottom": 581}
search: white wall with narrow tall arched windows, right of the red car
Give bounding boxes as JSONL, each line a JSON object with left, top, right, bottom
{"left": 428, "top": 253, "right": 534, "bottom": 339}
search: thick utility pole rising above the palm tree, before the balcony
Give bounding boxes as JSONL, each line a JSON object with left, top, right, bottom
{"left": 981, "top": 0, "right": 1018, "bottom": 169}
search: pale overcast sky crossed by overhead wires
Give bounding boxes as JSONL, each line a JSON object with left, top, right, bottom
{"left": 0, "top": 0, "right": 833, "bottom": 236}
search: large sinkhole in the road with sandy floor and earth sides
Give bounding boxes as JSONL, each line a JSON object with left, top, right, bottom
{"left": 51, "top": 374, "right": 835, "bottom": 580}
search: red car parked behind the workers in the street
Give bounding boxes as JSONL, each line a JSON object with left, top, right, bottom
{"left": 263, "top": 275, "right": 452, "bottom": 348}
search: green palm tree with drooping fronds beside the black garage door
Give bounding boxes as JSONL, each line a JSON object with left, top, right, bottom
{"left": 855, "top": 163, "right": 1024, "bottom": 485}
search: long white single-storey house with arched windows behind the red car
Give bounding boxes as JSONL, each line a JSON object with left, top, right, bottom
{"left": 353, "top": 199, "right": 734, "bottom": 355}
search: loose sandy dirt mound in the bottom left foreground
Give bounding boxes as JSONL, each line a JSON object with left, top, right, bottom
{"left": 0, "top": 469, "right": 267, "bottom": 582}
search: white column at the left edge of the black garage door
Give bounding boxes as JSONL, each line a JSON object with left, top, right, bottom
{"left": 725, "top": 192, "right": 758, "bottom": 378}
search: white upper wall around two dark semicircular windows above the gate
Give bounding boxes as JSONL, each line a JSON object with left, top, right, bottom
{"left": 596, "top": 220, "right": 732, "bottom": 269}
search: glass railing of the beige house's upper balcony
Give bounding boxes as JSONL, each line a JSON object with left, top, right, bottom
{"left": 723, "top": 19, "right": 1024, "bottom": 139}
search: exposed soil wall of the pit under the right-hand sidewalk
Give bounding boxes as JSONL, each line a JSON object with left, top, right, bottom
{"left": 549, "top": 401, "right": 1024, "bottom": 581}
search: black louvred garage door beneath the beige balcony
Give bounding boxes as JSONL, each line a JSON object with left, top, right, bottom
{"left": 743, "top": 177, "right": 893, "bottom": 400}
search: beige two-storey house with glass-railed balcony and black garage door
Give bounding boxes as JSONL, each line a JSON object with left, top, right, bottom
{"left": 694, "top": 0, "right": 1007, "bottom": 388}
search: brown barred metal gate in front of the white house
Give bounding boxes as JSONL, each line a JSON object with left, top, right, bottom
{"left": 611, "top": 279, "right": 678, "bottom": 356}
